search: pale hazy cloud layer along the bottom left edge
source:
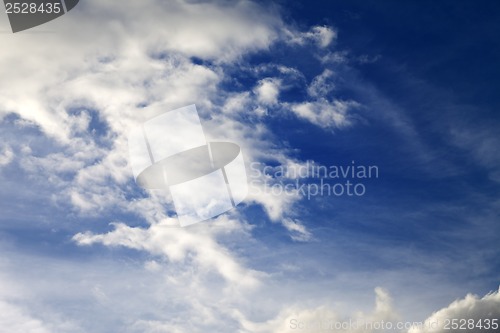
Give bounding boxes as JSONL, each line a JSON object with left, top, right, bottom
{"left": 0, "top": 239, "right": 256, "bottom": 333}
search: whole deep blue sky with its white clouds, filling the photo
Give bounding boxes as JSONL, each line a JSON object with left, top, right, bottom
{"left": 0, "top": 0, "right": 500, "bottom": 333}
